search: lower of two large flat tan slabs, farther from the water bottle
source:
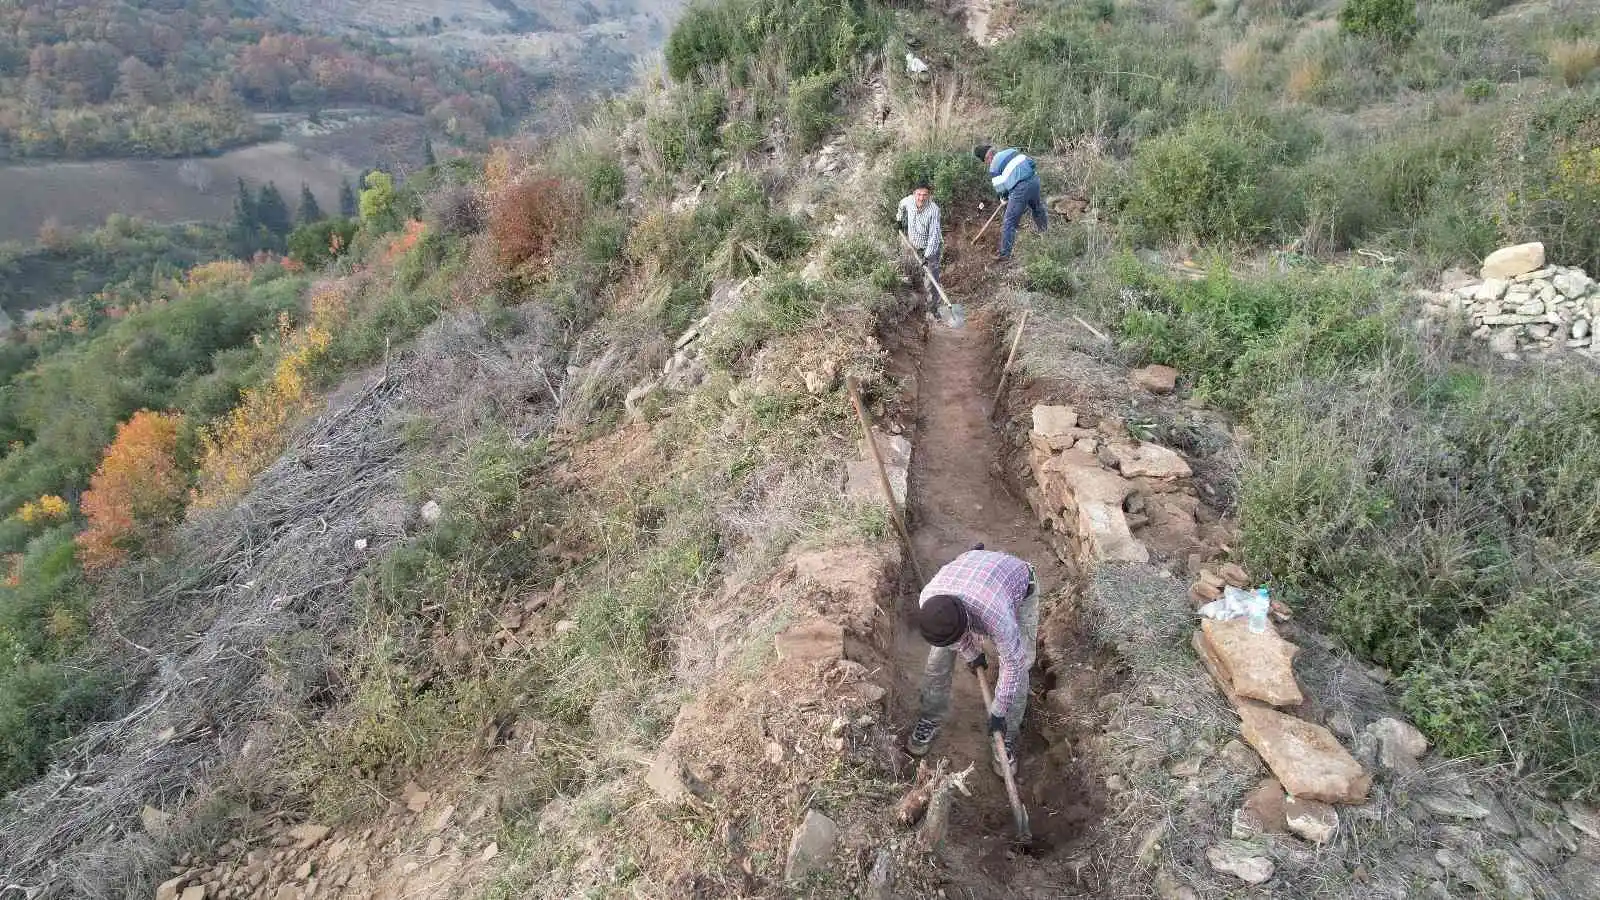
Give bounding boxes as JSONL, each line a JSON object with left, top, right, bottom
{"left": 1238, "top": 705, "right": 1373, "bottom": 802}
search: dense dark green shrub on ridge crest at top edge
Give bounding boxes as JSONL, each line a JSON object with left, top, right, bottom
{"left": 666, "top": 0, "right": 888, "bottom": 85}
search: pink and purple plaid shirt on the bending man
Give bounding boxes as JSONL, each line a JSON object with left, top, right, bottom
{"left": 917, "top": 549, "right": 1034, "bottom": 716}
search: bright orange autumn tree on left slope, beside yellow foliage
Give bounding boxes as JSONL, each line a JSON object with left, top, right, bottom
{"left": 78, "top": 410, "right": 186, "bottom": 572}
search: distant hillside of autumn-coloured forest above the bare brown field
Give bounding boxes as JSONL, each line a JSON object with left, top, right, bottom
{"left": 0, "top": 0, "right": 531, "bottom": 162}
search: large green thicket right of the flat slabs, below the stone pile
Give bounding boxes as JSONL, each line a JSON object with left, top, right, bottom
{"left": 1238, "top": 329, "right": 1600, "bottom": 794}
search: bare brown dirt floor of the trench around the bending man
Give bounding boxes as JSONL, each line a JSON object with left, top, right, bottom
{"left": 894, "top": 304, "right": 1096, "bottom": 898}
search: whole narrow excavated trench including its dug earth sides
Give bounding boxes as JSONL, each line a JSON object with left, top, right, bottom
{"left": 883, "top": 262, "right": 1110, "bottom": 898}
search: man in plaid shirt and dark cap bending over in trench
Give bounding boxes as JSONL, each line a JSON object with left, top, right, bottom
{"left": 906, "top": 544, "right": 1038, "bottom": 773}
